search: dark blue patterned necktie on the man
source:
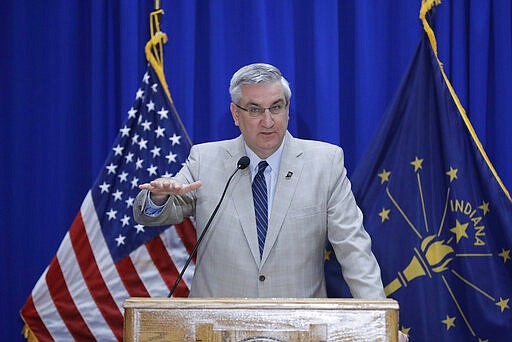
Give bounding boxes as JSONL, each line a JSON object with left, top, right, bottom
{"left": 252, "top": 160, "right": 268, "bottom": 257}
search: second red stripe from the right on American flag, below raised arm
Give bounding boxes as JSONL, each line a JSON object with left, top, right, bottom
{"left": 146, "top": 237, "right": 189, "bottom": 297}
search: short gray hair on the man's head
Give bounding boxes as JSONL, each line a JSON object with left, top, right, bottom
{"left": 229, "top": 63, "right": 292, "bottom": 104}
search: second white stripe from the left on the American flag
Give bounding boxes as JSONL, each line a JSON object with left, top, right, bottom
{"left": 57, "top": 232, "right": 116, "bottom": 341}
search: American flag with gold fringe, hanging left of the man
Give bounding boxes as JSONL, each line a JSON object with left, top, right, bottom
{"left": 21, "top": 65, "right": 196, "bottom": 341}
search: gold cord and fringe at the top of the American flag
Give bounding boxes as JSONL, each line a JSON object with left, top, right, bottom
{"left": 145, "top": 0, "right": 192, "bottom": 145}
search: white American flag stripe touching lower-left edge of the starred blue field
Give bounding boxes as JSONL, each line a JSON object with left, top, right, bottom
{"left": 80, "top": 190, "right": 130, "bottom": 314}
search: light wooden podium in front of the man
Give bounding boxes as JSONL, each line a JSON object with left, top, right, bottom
{"left": 124, "top": 298, "right": 398, "bottom": 342}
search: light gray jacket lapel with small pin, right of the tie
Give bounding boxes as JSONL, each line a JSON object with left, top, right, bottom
{"left": 260, "top": 133, "right": 304, "bottom": 267}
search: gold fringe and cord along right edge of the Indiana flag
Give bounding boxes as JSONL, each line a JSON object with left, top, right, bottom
{"left": 420, "top": 0, "right": 512, "bottom": 202}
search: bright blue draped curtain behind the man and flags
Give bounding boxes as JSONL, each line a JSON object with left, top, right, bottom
{"left": 0, "top": 0, "right": 512, "bottom": 341}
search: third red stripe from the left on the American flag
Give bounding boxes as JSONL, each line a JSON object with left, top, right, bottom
{"left": 69, "top": 212, "right": 123, "bottom": 340}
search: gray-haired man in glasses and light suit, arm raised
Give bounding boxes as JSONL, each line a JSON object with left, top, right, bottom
{"left": 134, "top": 64, "right": 385, "bottom": 299}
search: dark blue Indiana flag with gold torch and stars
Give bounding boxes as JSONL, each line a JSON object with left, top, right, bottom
{"left": 326, "top": 3, "right": 512, "bottom": 341}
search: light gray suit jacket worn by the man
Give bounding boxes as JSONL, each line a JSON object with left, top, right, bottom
{"left": 134, "top": 133, "right": 385, "bottom": 299}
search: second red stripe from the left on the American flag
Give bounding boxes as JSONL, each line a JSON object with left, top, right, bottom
{"left": 46, "top": 257, "right": 94, "bottom": 340}
